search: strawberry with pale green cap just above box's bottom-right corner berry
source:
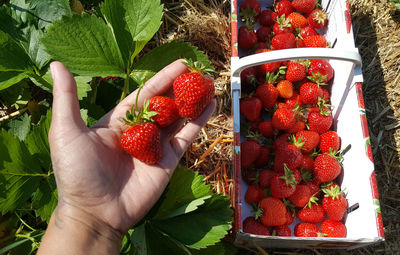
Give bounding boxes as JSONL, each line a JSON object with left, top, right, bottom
{"left": 322, "top": 183, "right": 348, "bottom": 221}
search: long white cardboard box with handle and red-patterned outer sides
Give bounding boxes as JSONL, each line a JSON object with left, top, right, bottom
{"left": 231, "top": 0, "right": 384, "bottom": 249}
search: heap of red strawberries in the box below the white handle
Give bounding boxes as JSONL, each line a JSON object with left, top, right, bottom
{"left": 240, "top": 59, "right": 348, "bottom": 237}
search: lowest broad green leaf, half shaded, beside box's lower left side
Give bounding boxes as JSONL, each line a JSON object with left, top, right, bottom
{"left": 154, "top": 194, "right": 232, "bottom": 249}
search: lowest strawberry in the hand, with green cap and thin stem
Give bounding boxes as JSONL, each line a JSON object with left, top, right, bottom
{"left": 121, "top": 100, "right": 161, "bottom": 165}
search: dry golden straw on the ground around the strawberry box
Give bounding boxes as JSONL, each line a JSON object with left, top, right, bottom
{"left": 156, "top": 0, "right": 400, "bottom": 254}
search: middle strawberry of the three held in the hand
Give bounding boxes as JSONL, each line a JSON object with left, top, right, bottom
{"left": 149, "top": 96, "right": 179, "bottom": 127}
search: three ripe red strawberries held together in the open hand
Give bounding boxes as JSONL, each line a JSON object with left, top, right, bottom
{"left": 121, "top": 60, "right": 215, "bottom": 165}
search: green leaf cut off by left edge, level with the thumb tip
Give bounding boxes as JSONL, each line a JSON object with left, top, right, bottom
{"left": 0, "top": 30, "right": 33, "bottom": 72}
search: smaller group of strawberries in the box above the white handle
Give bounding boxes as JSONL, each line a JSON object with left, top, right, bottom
{"left": 238, "top": 0, "right": 328, "bottom": 53}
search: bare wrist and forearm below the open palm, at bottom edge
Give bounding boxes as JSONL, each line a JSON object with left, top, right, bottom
{"left": 38, "top": 202, "right": 123, "bottom": 255}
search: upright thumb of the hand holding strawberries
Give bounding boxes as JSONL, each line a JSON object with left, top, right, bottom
{"left": 50, "top": 61, "right": 87, "bottom": 132}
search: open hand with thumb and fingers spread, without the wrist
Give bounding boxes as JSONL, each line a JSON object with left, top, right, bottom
{"left": 49, "top": 61, "right": 215, "bottom": 233}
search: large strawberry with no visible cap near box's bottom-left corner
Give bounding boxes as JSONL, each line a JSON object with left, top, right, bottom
{"left": 260, "top": 197, "right": 287, "bottom": 226}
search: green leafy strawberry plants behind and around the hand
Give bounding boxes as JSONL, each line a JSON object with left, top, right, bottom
{"left": 0, "top": 0, "right": 235, "bottom": 255}
